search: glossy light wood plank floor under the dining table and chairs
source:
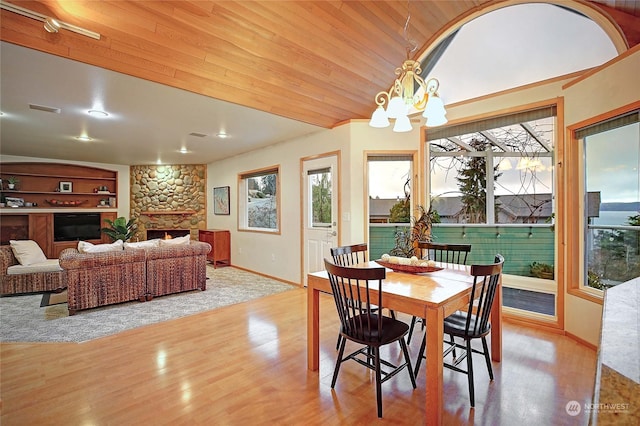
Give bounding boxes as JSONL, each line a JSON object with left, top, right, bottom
{"left": 0, "top": 289, "right": 596, "bottom": 426}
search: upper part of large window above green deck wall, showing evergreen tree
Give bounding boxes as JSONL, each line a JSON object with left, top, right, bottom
{"left": 427, "top": 107, "right": 555, "bottom": 224}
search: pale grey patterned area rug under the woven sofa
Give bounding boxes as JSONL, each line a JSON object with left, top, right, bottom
{"left": 0, "top": 266, "right": 297, "bottom": 342}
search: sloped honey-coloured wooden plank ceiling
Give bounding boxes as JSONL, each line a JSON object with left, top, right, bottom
{"left": 0, "top": 0, "right": 639, "bottom": 128}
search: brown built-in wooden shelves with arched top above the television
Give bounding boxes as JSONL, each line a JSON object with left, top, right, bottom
{"left": 0, "top": 163, "right": 118, "bottom": 209}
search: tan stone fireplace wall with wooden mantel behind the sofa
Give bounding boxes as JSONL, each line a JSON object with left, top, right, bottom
{"left": 129, "top": 164, "right": 207, "bottom": 241}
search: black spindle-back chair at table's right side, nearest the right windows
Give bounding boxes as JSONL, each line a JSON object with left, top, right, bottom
{"left": 415, "top": 254, "right": 504, "bottom": 407}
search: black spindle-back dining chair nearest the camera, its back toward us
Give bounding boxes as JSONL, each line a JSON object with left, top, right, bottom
{"left": 324, "top": 259, "right": 416, "bottom": 417}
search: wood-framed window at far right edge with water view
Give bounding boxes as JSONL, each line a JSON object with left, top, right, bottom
{"left": 576, "top": 111, "right": 640, "bottom": 290}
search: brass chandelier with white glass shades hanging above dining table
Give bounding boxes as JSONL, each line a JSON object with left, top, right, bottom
{"left": 369, "top": 10, "right": 447, "bottom": 132}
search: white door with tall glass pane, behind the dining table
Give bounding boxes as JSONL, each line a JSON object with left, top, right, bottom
{"left": 303, "top": 155, "right": 338, "bottom": 286}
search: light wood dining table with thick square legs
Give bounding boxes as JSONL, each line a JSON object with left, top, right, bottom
{"left": 307, "top": 261, "right": 502, "bottom": 425}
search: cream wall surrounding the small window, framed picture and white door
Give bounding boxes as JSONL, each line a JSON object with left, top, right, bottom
{"left": 207, "top": 126, "right": 349, "bottom": 283}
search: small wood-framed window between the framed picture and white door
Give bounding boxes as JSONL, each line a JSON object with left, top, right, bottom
{"left": 238, "top": 166, "right": 280, "bottom": 233}
